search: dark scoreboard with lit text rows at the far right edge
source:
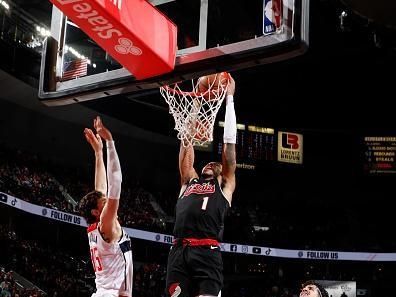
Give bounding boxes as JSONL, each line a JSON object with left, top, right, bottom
{"left": 364, "top": 136, "right": 396, "bottom": 174}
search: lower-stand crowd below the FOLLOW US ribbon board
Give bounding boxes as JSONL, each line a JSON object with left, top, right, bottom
{"left": 0, "top": 217, "right": 395, "bottom": 297}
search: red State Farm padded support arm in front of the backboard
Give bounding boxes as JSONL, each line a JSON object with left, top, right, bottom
{"left": 50, "top": 0, "right": 177, "bottom": 79}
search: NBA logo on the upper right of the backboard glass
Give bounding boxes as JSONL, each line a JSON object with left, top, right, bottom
{"left": 263, "top": 0, "right": 283, "bottom": 35}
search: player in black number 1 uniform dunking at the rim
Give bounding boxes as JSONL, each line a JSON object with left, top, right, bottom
{"left": 166, "top": 78, "right": 237, "bottom": 297}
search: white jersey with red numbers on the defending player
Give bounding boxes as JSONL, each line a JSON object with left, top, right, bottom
{"left": 87, "top": 223, "right": 133, "bottom": 297}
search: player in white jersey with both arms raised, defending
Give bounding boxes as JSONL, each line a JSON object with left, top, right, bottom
{"left": 79, "top": 117, "right": 133, "bottom": 297}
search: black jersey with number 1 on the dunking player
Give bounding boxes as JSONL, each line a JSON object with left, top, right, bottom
{"left": 173, "top": 178, "right": 230, "bottom": 241}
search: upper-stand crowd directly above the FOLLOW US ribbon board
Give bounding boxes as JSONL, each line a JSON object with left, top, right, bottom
{"left": 0, "top": 146, "right": 396, "bottom": 251}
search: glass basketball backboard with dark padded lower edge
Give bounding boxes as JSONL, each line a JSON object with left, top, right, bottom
{"left": 39, "top": 0, "right": 309, "bottom": 105}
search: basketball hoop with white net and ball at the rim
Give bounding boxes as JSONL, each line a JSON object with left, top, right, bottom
{"left": 160, "top": 72, "right": 230, "bottom": 146}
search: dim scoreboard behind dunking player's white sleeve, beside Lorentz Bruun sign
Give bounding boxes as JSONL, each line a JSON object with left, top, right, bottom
{"left": 214, "top": 122, "right": 277, "bottom": 170}
